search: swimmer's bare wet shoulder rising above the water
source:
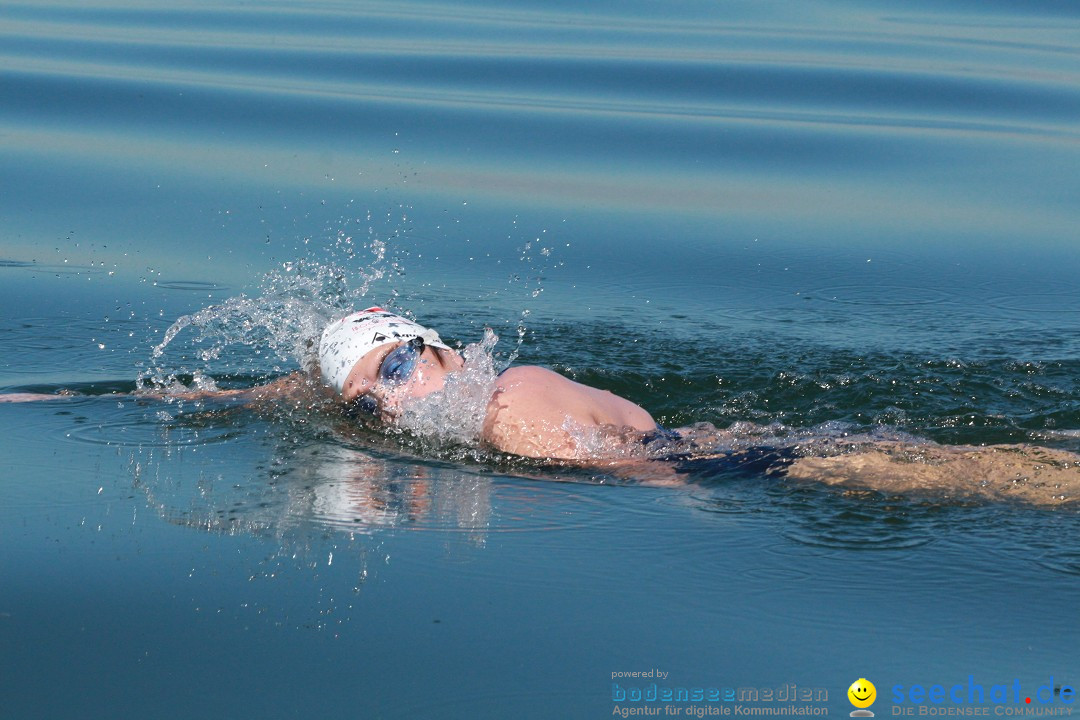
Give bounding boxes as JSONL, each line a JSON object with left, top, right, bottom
{"left": 484, "top": 365, "right": 657, "bottom": 460}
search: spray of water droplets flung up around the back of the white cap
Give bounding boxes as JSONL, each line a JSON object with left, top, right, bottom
{"left": 137, "top": 213, "right": 563, "bottom": 392}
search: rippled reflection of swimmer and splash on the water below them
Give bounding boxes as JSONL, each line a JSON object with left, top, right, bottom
{"left": 126, "top": 399, "right": 635, "bottom": 547}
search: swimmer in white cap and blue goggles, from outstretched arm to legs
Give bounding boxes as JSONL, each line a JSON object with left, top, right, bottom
{"left": 6, "top": 308, "right": 1080, "bottom": 505}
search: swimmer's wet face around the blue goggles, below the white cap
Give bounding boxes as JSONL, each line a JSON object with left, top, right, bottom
{"left": 341, "top": 342, "right": 461, "bottom": 421}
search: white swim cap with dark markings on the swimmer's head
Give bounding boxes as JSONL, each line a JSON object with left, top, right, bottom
{"left": 319, "top": 308, "right": 449, "bottom": 393}
